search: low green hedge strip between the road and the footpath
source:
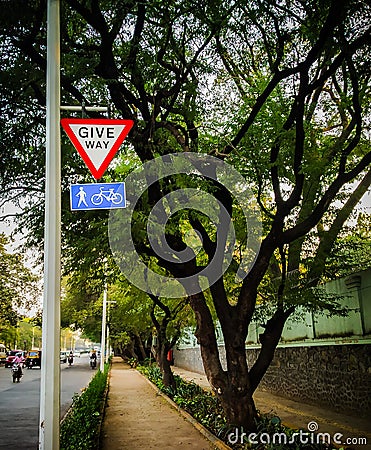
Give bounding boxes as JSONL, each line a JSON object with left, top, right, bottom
{"left": 60, "top": 364, "right": 109, "bottom": 450}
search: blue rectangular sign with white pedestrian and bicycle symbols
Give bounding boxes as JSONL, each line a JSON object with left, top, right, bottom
{"left": 70, "top": 182, "right": 126, "bottom": 211}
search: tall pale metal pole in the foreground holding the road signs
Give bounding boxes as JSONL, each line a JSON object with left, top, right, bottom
{"left": 39, "top": 0, "right": 61, "bottom": 450}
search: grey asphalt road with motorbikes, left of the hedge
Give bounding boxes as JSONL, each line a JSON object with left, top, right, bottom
{"left": 0, "top": 355, "right": 99, "bottom": 450}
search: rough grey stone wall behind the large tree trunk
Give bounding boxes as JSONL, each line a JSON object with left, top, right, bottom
{"left": 174, "top": 344, "right": 371, "bottom": 418}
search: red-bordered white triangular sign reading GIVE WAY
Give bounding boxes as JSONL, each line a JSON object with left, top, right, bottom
{"left": 61, "top": 119, "right": 134, "bottom": 180}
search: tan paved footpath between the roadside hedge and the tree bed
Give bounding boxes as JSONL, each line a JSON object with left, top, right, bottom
{"left": 101, "top": 357, "right": 222, "bottom": 450}
